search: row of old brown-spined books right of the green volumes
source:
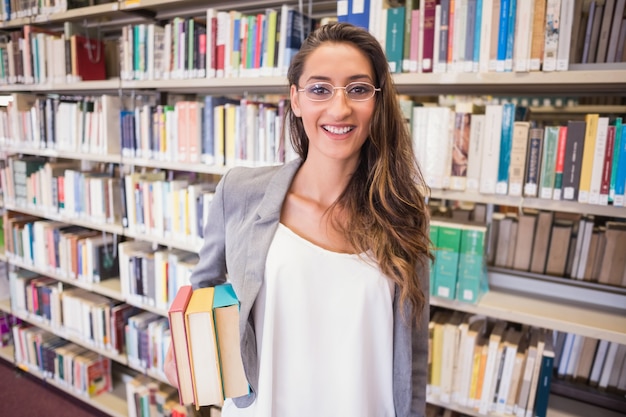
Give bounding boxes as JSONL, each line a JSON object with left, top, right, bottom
{"left": 487, "top": 209, "right": 626, "bottom": 287}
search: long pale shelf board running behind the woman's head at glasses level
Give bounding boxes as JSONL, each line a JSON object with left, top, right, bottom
{"left": 0, "top": 69, "right": 626, "bottom": 96}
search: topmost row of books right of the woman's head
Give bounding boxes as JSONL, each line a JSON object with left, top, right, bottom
{"left": 337, "top": 0, "right": 626, "bottom": 73}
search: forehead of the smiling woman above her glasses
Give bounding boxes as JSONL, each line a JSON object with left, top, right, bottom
{"left": 300, "top": 42, "right": 374, "bottom": 81}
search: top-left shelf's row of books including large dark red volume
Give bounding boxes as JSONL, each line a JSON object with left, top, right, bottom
{"left": 0, "top": 5, "right": 314, "bottom": 84}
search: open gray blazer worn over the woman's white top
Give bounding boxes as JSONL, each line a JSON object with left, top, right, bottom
{"left": 191, "top": 160, "right": 428, "bottom": 417}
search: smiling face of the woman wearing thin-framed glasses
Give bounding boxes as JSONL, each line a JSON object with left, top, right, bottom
{"left": 291, "top": 43, "right": 378, "bottom": 166}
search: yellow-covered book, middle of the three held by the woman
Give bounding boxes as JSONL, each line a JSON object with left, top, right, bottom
{"left": 185, "top": 287, "right": 224, "bottom": 408}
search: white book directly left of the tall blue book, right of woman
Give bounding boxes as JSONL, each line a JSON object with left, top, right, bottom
{"left": 480, "top": 104, "right": 502, "bottom": 194}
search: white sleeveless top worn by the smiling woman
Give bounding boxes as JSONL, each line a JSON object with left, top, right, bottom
{"left": 222, "top": 224, "right": 395, "bottom": 417}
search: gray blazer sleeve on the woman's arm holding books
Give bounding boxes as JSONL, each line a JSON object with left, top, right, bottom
{"left": 190, "top": 173, "right": 228, "bottom": 290}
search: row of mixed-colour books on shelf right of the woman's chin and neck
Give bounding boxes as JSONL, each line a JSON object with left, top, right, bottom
{"left": 404, "top": 102, "right": 626, "bottom": 206}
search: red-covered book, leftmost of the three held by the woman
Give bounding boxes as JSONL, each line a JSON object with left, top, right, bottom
{"left": 167, "top": 285, "right": 194, "bottom": 405}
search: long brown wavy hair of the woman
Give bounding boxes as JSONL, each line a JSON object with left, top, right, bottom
{"left": 286, "top": 22, "right": 433, "bottom": 321}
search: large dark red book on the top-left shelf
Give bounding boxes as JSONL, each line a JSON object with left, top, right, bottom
{"left": 70, "top": 35, "right": 106, "bottom": 81}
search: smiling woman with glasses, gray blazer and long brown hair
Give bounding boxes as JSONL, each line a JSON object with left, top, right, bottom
{"left": 167, "top": 23, "right": 430, "bottom": 417}
